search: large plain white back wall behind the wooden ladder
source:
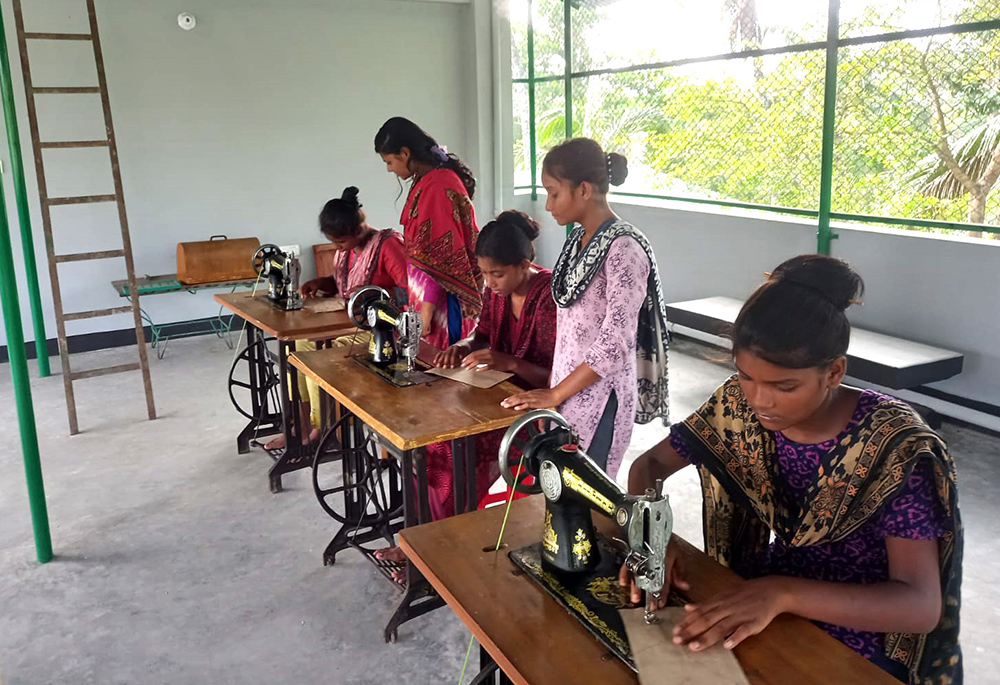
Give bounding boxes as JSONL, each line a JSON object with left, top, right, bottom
{"left": 0, "top": 0, "right": 493, "bottom": 342}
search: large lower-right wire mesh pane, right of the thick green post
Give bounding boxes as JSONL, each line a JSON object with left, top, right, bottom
{"left": 833, "top": 24, "right": 1000, "bottom": 225}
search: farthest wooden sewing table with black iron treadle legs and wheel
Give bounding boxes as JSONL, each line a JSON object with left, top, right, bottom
{"left": 215, "top": 293, "right": 356, "bottom": 492}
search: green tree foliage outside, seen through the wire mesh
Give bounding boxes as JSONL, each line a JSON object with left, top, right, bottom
{"left": 517, "top": 0, "right": 1000, "bottom": 232}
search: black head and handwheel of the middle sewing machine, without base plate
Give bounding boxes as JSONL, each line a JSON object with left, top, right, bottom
{"left": 347, "top": 285, "right": 422, "bottom": 372}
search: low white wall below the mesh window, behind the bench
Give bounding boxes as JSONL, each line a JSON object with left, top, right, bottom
{"left": 510, "top": 195, "right": 1000, "bottom": 412}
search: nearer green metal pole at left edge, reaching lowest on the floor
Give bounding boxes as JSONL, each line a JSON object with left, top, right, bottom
{"left": 0, "top": 148, "right": 52, "bottom": 564}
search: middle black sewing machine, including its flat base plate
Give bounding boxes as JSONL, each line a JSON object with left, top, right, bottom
{"left": 347, "top": 285, "right": 434, "bottom": 387}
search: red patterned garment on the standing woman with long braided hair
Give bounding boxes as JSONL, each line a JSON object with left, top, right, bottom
{"left": 400, "top": 169, "right": 483, "bottom": 350}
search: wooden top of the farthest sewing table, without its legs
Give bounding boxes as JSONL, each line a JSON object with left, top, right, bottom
{"left": 215, "top": 292, "right": 355, "bottom": 340}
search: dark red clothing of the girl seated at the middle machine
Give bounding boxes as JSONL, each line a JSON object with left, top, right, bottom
{"left": 427, "top": 268, "right": 556, "bottom": 521}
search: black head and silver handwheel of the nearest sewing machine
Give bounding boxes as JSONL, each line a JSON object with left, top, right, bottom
{"left": 499, "top": 409, "right": 673, "bottom": 620}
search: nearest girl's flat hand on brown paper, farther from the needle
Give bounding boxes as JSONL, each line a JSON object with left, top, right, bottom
{"left": 674, "top": 576, "right": 788, "bottom": 651}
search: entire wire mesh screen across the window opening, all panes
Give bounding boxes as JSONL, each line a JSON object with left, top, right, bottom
{"left": 511, "top": 0, "right": 1000, "bottom": 231}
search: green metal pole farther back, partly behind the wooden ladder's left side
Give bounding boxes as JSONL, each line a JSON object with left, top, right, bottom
{"left": 0, "top": 4, "right": 50, "bottom": 378}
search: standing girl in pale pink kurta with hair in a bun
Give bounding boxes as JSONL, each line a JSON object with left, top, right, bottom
{"left": 504, "top": 138, "right": 668, "bottom": 476}
